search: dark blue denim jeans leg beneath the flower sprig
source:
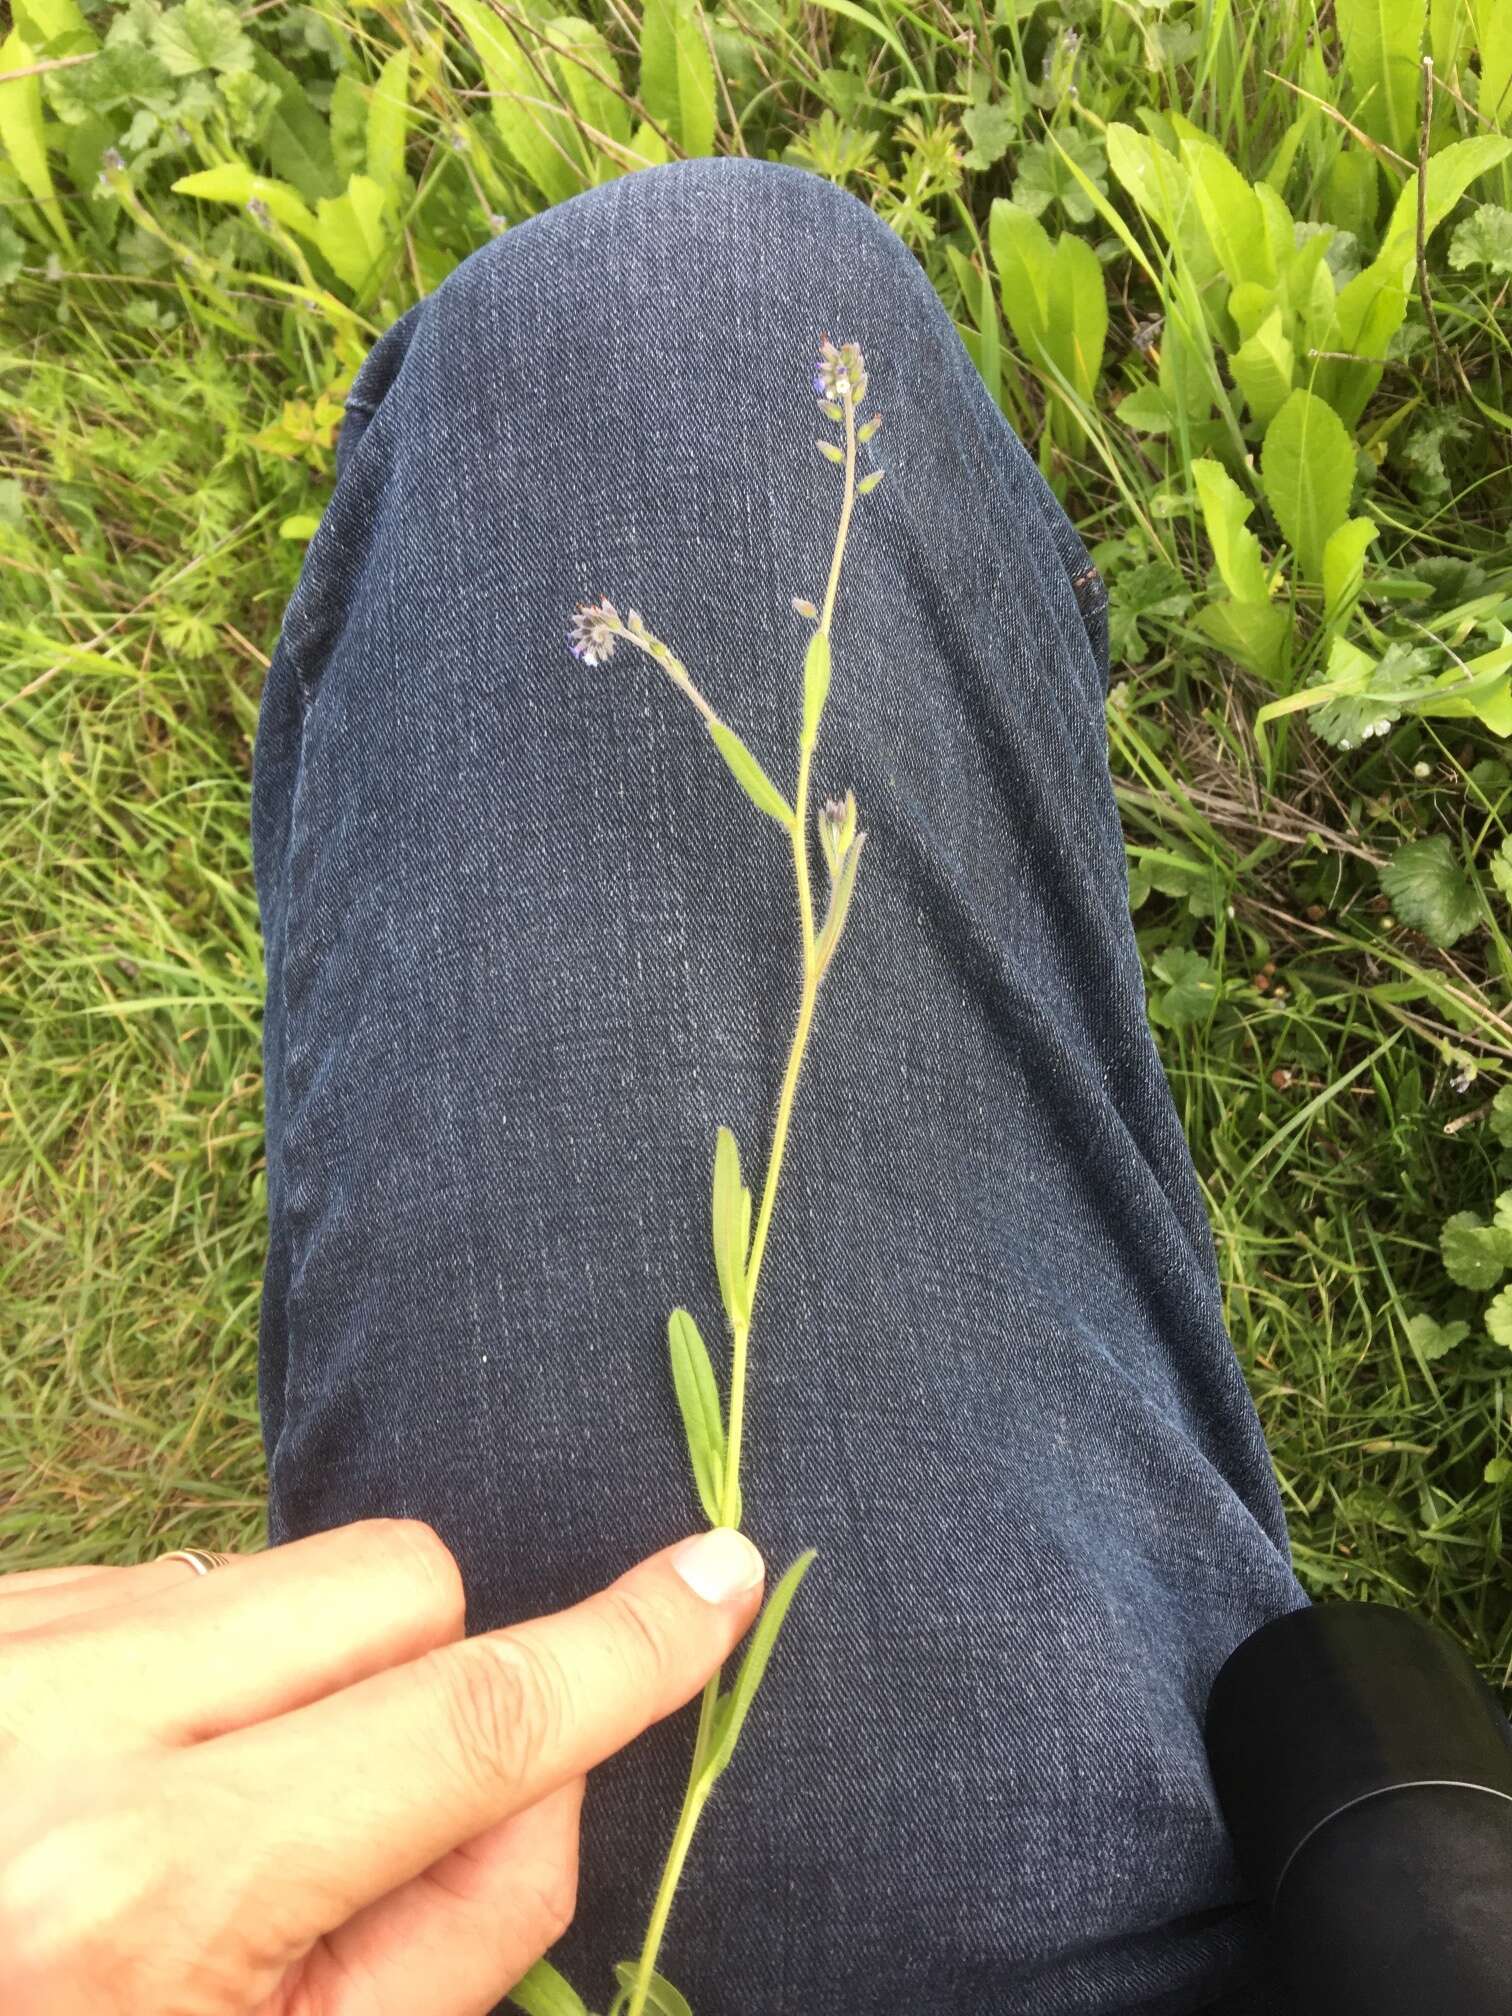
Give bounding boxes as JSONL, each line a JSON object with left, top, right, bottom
{"left": 254, "top": 161, "right": 1306, "bottom": 2016}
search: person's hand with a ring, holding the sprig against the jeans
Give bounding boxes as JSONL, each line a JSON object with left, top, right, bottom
{"left": 0, "top": 1520, "right": 760, "bottom": 2016}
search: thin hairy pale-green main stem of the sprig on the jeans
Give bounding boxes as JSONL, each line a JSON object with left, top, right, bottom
{"left": 627, "top": 374, "right": 857, "bottom": 2016}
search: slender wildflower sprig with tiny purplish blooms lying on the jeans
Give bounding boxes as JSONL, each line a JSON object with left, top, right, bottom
{"left": 512, "top": 337, "right": 883, "bottom": 2016}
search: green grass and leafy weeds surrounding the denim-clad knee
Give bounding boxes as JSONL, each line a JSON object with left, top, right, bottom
{"left": 0, "top": 0, "right": 1512, "bottom": 1685}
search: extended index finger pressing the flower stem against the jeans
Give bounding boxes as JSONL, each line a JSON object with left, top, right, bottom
{"left": 165, "top": 1528, "right": 764, "bottom": 1945}
